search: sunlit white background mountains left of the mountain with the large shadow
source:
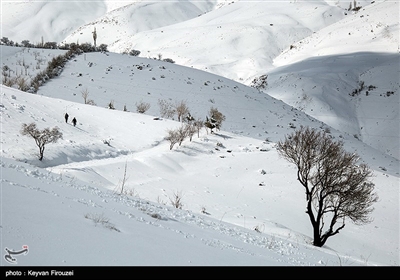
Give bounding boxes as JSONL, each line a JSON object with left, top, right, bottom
{"left": 2, "top": 0, "right": 370, "bottom": 82}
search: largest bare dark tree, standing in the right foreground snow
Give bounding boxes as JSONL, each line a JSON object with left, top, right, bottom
{"left": 277, "top": 126, "right": 378, "bottom": 247}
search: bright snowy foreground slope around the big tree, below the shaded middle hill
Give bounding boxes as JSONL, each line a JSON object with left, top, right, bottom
{"left": 1, "top": 83, "right": 399, "bottom": 265}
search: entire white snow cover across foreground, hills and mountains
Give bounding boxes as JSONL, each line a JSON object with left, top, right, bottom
{"left": 0, "top": 1, "right": 400, "bottom": 266}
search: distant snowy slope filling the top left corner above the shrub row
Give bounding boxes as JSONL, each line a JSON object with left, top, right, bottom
{"left": 1, "top": 0, "right": 108, "bottom": 44}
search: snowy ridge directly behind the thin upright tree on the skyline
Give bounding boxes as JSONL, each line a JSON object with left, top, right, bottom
{"left": 63, "top": 0, "right": 218, "bottom": 48}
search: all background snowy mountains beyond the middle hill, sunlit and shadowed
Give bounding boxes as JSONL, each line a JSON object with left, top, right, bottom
{"left": 2, "top": 0, "right": 400, "bottom": 159}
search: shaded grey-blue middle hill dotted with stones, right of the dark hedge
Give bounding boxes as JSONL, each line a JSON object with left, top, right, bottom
{"left": 38, "top": 50, "right": 323, "bottom": 145}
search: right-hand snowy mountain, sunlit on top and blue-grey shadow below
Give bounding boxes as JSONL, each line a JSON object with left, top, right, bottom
{"left": 264, "top": 1, "right": 400, "bottom": 159}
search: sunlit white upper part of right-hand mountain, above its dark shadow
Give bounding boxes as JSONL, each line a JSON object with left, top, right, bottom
{"left": 274, "top": 1, "right": 400, "bottom": 67}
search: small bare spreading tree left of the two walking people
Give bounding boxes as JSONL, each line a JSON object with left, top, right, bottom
{"left": 21, "top": 123, "right": 62, "bottom": 160}
